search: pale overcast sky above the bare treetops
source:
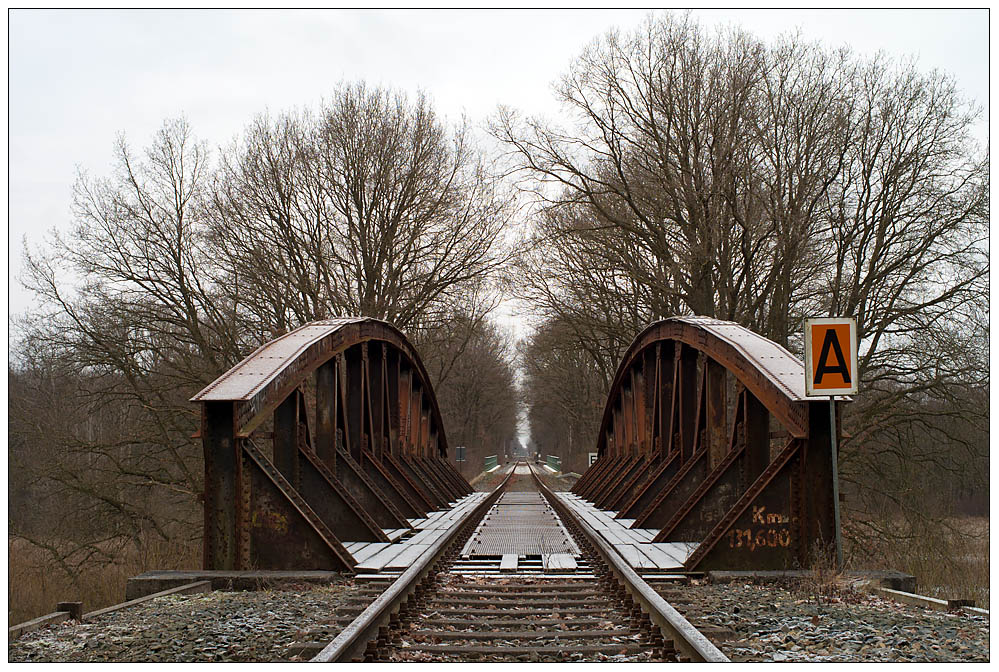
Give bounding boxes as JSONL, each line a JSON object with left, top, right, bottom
{"left": 8, "top": 10, "right": 989, "bottom": 326}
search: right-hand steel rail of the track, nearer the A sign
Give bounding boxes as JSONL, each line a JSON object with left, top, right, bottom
{"left": 528, "top": 464, "right": 731, "bottom": 663}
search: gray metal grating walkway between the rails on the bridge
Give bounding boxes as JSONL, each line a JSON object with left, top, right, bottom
{"left": 461, "top": 491, "right": 579, "bottom": 557}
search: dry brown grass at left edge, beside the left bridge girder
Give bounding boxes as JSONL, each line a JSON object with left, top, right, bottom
{"left": 7, "top": 537, "right": 201, "bottom": 626}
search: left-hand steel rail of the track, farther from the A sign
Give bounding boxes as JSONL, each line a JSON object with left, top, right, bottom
{"left": 309, "top": 465, "right": 516, "bottom": 663}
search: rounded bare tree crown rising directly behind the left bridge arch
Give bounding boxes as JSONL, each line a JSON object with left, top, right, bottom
{"left": 212, "top": 84, "right": 513, "bottom": 336}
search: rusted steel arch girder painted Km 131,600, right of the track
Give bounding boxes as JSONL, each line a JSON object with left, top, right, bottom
{"left": 573, "top": 317, "right": 846, "bottom": 570}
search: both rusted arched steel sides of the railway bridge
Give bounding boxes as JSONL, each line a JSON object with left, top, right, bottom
{"left": 193, "top": 317, "right": 838, "bottom": 572}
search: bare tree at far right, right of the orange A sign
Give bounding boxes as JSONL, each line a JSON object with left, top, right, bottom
{"left": 811, "top": 59, "right": 989, "bottom": 536}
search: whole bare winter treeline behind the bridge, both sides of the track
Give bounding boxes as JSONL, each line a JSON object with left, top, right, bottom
{"left": 8, "top": 14, "right": 989, "bottom": 584}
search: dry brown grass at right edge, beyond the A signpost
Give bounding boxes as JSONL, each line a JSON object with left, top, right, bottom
{"left": 858, "top": 518, "right": 989, "bottom": 609}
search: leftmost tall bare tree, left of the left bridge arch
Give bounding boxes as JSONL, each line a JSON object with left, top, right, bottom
{"left": 19, "top": 122, "right": 223, "bottom": 539}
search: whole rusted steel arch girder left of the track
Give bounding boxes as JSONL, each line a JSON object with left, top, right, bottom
{"left": 192, "top": 318, "right": 471, "bottom": 571}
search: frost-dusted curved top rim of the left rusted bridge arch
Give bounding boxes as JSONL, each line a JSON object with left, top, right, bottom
{"left": 191, "top": 317, "right": 447, "bottom": 456}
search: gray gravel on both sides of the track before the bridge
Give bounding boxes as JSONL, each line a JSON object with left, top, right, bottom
{"left": 8, "top": 580, "right": 989, "bottom": 662}
